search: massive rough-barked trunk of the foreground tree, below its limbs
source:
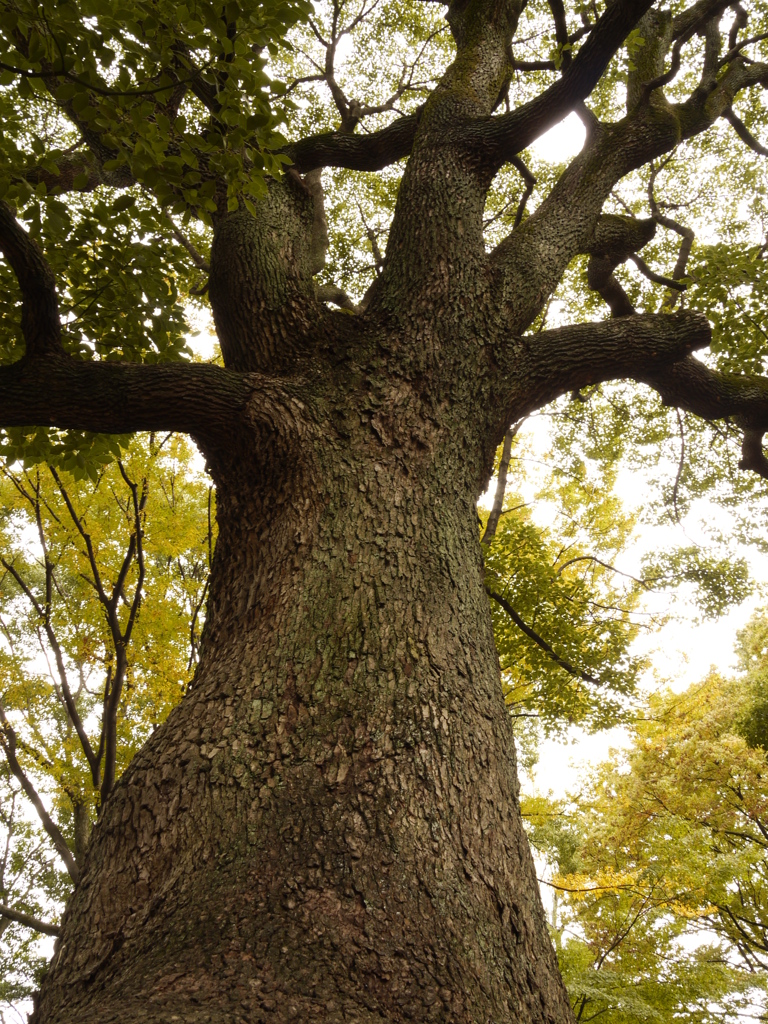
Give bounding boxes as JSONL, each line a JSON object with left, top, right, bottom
{"left": 35, "top": 316, "right": 570, "bottom": 1024}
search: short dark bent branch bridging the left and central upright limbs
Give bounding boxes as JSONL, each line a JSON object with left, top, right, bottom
{"left": 285, "top": 111, "right": 421, "bottom": 174}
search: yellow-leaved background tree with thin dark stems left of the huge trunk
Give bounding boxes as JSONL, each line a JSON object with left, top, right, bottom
{"left": 0, "top": 435, "right": 213, "bottom": 1000}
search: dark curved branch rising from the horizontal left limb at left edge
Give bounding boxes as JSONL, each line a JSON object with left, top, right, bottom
{"left": 0, "top": 201, "right": 61, "bottom": 355}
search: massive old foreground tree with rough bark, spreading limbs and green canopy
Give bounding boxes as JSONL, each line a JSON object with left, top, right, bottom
{"left": 0, "top": 0, "right": 768, "bottom": 1024}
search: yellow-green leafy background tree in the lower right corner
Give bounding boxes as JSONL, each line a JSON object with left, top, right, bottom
{"left": 530, "top": 634, "right": 768, "bottom": 1022}
